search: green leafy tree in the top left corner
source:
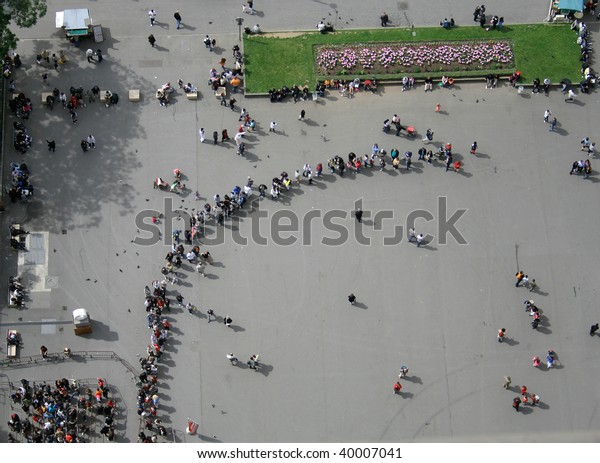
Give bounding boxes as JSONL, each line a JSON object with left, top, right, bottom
{"left": 0, "top": 0, "right": 48, "bottom": 57}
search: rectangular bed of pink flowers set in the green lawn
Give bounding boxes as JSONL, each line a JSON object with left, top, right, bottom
{"left": 315, "top": 40, "right": 514, "bottom": 76}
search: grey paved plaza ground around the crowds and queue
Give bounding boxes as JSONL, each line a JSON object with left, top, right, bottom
{"left": 0, "top": 0, "right": 600, "bottom": 443}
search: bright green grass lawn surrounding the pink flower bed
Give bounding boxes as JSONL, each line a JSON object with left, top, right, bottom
{"left": 244, "top": 24, "right": 581, "bottom": 93}
